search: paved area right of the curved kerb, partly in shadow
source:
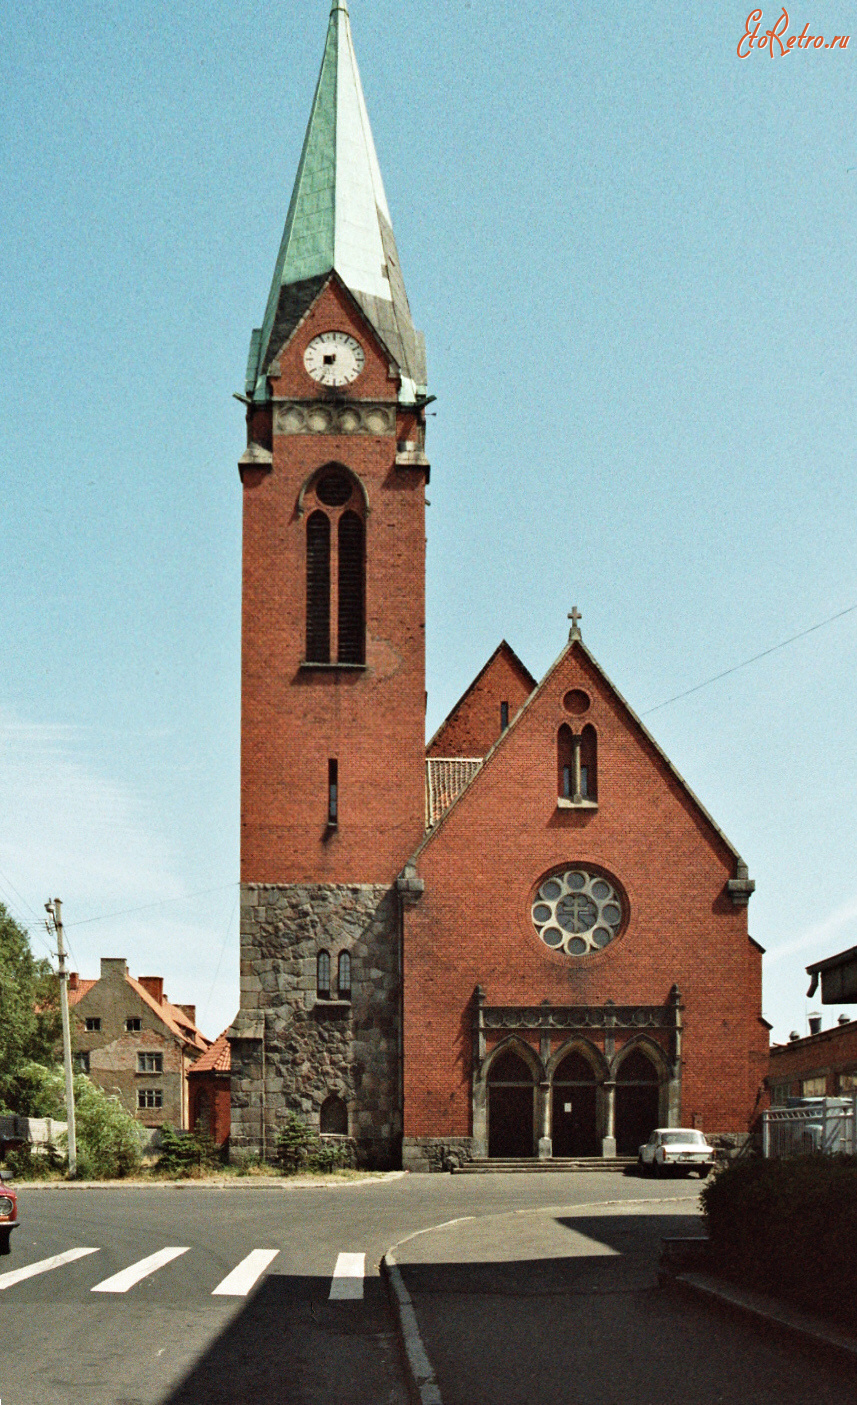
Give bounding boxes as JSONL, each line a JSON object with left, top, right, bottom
{"left": 385, "top": 1197, "right": 854, "bottom": 1405}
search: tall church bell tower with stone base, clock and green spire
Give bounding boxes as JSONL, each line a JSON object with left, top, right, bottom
{"left": 230, "top": 0, "right": 429, "bottom": 1161}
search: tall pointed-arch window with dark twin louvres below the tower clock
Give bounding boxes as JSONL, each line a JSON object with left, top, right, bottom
{"left": 306, "top": 464, "right": 365, "bottom": 665}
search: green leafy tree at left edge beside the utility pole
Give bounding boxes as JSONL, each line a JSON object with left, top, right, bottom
{"left": 0, "top": 903, "right": 60, "bottom": 1116}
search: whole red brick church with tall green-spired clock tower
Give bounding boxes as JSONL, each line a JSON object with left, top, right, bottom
{"left": 229, "top": 0, "right": 767, "bottom": 1169}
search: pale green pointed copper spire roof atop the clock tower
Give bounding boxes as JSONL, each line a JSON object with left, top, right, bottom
{"left": 247, "top": 0, "right": 426, "bottom": 400}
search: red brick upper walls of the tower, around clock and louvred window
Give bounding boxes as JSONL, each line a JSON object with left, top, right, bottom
{"left": 242, "top": 281, "right": 426, "bottom": 884}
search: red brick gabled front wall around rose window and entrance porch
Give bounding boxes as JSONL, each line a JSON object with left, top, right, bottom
{"left": 403, "top": 648, "right": 767, "bottom": 1157}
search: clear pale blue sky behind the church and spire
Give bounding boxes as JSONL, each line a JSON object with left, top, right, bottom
{"left": 0, "top": 0, "right": 857, "bottom": 1038}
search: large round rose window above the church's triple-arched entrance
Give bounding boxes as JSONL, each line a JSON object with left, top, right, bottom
{"left": 531, "top": 868, "right": 625, "bottom": 957}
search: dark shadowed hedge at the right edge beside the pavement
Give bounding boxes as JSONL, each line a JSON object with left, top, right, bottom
{"left": 701, "top": 1155, "right": 857, "bottom": 1326}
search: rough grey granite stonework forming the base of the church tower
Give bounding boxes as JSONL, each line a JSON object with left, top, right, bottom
{"left": 230, "top": 884, "right": 402, "bottom": 1165}
